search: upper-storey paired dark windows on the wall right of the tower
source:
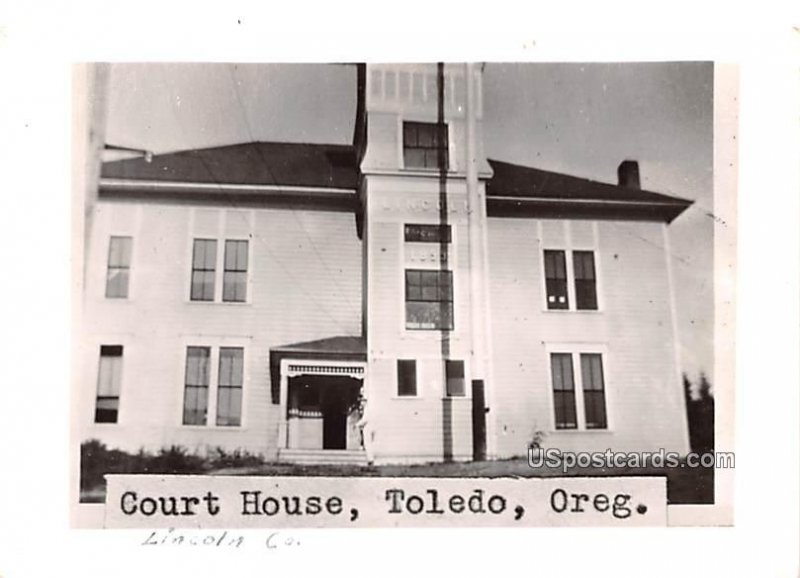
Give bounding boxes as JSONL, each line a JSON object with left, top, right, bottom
{"left": 544, "top": 250, "right": 598, "bottom": 311}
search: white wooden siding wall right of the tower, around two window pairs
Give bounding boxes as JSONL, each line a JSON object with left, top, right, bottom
{"left": 488, "top": 219, "right": 688, "bottom": 457}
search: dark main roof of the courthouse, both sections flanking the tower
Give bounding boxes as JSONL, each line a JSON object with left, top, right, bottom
{"left": 101, "top": 142, "right": 691, "bottom": 222}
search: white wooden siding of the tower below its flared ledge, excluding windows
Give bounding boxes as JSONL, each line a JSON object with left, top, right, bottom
{"left": 367, "top": 176, "right": 472, "bottom": 463}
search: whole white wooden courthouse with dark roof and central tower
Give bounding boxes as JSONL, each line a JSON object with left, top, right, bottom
{"left": 76, "top": 64, "right": 690, "bottom": 463}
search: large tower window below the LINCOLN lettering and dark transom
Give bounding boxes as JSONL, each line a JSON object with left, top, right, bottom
{"left": 406, "top": 269, "right": 453, "bottom": 331}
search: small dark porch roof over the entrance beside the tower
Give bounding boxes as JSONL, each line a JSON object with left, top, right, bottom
{"left": 269, "top": 335, "right": 367, "bottom": 404}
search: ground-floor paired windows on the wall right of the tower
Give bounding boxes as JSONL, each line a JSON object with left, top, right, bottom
{"left": 550, "top": 353, "right": 608, "bottom": 429}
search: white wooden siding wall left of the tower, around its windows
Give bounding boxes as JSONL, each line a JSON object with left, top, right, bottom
{"left": 79, "top": 201, "right": 362, "bottom": 456}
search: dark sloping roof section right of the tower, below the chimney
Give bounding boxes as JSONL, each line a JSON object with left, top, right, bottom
{"left": 486, "top": 159, "right": 692, "bottom": 222}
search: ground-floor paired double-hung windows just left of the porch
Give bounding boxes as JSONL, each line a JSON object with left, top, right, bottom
{"left": 183, "top": 346, "right": 244, "bottom": 426}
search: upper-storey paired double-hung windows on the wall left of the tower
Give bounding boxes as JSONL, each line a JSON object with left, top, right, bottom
{"left": 190, "top": 239, "right": 248, "bottom": 303}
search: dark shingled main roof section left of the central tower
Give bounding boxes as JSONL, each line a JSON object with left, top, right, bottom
{"left": 101, "top": 142, "right": 358, "bottom": 189}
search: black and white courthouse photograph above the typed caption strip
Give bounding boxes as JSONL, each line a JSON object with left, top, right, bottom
{"left": 73, "top": 62, "right": 735, "bottom": 525}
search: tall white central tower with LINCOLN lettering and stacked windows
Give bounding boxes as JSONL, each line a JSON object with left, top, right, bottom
{"left": 356, "top": 64, "right": 491, "bottom": 462}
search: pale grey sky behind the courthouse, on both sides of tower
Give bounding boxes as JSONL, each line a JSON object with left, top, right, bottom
{"left": 106, "top": 62, "right": 714, "bottom": 383}
